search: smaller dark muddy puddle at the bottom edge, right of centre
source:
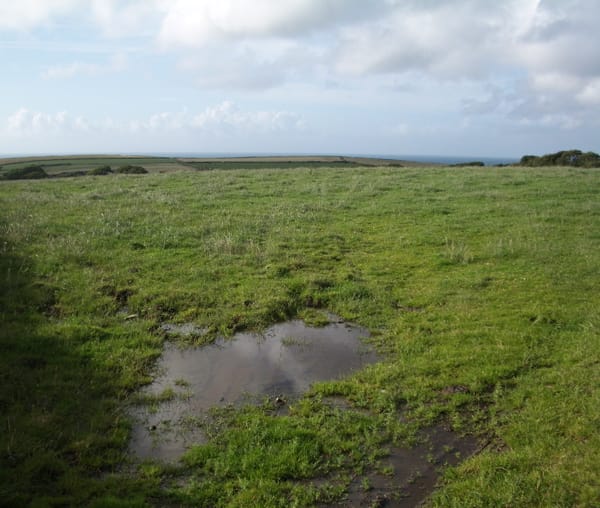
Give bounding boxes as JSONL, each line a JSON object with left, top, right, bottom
{"left": 344, "top": 426, "right": 479, "bottom": 508}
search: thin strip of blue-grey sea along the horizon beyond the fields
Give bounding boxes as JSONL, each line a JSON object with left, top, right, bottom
{"left": 0, "top": 152, "right": 519, "bottom": 166}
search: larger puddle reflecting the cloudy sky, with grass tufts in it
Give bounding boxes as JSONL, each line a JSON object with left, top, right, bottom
{"left": 130, "top": 320, "right": 377, "bottom": 461}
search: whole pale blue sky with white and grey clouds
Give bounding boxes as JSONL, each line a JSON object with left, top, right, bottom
{"left": 0, "top": 0, "right": 600, "bottom": 157}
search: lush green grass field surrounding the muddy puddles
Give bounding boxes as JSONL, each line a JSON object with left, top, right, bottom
{"left": 0, "top": 165, "right": 600, "bottom": 506}
